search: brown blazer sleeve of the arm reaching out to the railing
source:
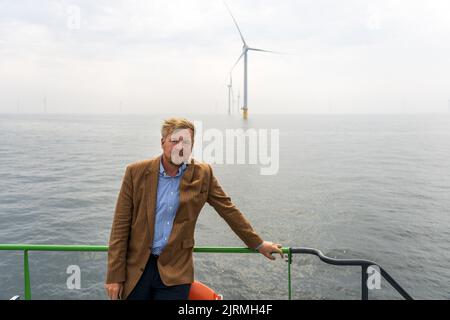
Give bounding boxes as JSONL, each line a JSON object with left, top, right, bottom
{"left": 206, "top": 165, "right": 263, "bottom": 249}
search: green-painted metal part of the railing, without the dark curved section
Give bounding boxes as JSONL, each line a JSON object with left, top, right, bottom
{"left": 0, "top": 244, "right": 292, "bottom": 300}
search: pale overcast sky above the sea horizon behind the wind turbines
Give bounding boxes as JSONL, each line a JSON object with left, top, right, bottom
{"left": 0, "top": 0, "right": 450, "bottom": 113}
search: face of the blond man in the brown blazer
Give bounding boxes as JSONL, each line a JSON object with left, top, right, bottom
{"left": 161, "top": 129, "right": 193, "bottom": 166}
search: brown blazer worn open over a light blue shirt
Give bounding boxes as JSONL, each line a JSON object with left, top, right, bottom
{"left": 106, "top": 156, "right": 263, "bottom": 299}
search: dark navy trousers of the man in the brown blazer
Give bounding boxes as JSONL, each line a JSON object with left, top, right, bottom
{"left": 127, "top": 255, "right": 191, "bottom": 300}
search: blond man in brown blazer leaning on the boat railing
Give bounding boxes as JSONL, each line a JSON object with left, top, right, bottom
{"left": 105, "top": 118, "right": 283, "bottom": 300}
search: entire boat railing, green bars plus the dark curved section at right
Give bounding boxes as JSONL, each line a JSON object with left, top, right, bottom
{"left": 0, "top": 244, "right": 412, "bottom": 300}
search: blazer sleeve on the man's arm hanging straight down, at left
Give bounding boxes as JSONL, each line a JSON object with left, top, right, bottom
{"left": 106, "top": 166, "right": 133, "bottom": 283}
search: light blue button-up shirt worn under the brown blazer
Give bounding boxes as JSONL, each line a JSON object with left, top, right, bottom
{"left": 152, "top": 159, "right": 187, "bottom": 255}
